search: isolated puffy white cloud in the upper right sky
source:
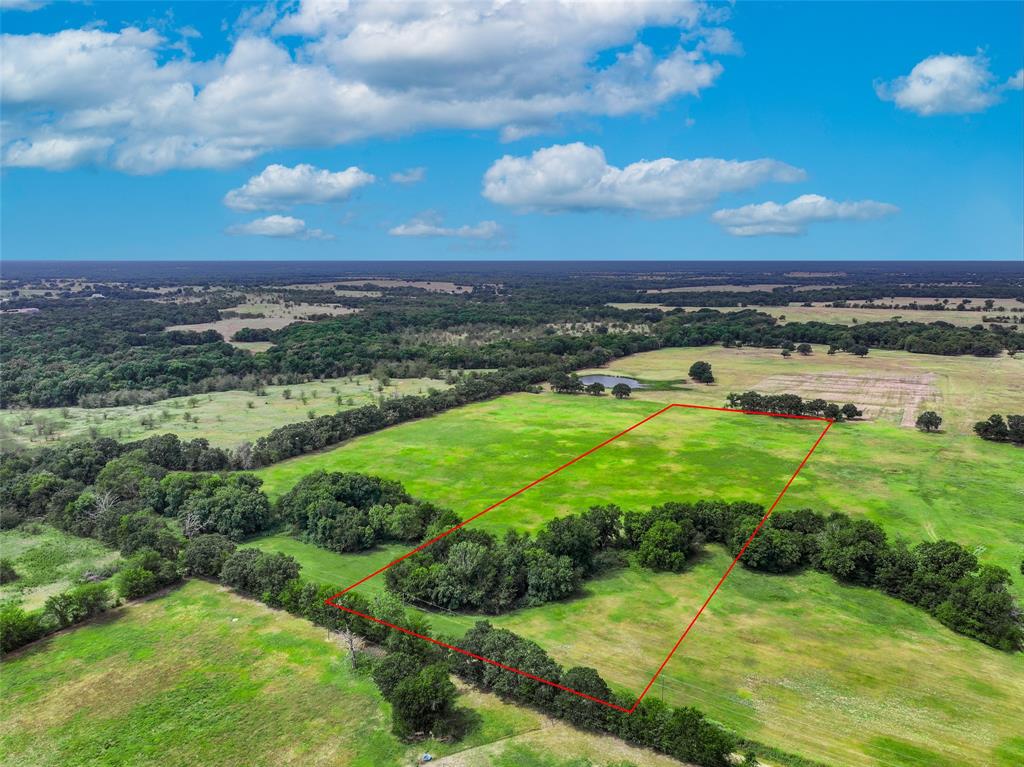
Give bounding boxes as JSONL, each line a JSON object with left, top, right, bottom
{"left": 874, "top": 53, "right": 1024, "bottom": 117}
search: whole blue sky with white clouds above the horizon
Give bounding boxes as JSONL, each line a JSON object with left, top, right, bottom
{"left": 0, "top": 0, "right": 1024, "bottom": 260}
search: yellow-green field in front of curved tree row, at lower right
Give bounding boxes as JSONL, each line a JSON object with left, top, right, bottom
{"left": 494, "top": 547, "right": 1024, "bottom": 767}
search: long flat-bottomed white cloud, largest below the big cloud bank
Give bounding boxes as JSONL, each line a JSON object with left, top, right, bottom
{"left": 483, "top": 143, "right": 806, "bottom": 216}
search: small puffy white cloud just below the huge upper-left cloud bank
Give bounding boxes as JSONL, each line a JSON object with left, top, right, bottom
{"left": 224, "top": 164, "right": 376, "bottom": 210}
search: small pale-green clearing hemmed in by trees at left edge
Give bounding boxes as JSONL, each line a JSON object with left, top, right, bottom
{"left": 0, "top": 522, "right": 120, "bottom": 610}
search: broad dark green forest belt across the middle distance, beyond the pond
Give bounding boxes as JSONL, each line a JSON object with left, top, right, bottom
{"left": 0, "top": 283, "right": 1024, "bottom": 408}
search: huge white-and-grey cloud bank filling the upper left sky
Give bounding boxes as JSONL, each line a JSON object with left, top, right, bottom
{"left": 0, "top": 0, "right": 735, "bottom": 173}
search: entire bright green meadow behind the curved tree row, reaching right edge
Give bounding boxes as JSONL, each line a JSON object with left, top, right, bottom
{"left": 257, "top": 391, "right": 1024, "bottom": 595}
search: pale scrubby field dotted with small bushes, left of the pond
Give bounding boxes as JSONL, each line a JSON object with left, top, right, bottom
{"left": 0, "top": 376, "right": 447, "bottom": 448}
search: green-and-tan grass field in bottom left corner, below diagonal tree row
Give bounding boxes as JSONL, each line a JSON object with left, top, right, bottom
{"left": 0, "top": 581, "right": 678, "bottom": 767}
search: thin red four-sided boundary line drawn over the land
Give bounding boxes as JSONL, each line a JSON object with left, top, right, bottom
{"left": 325, "top": 403, "right": 835, "bottom": 714}
